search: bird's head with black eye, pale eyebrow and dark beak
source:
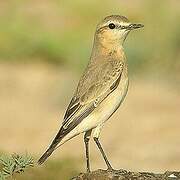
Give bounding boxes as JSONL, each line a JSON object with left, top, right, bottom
{"left": 95, "top": 15, "right": 144, "bottom": 45}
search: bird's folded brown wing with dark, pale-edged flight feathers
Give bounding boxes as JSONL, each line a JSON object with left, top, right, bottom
{"left": 59, "top": 61, "right": 124, "bottom": 136}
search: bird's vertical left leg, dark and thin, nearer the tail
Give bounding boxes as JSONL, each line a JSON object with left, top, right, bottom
{"left": 84, "top": 130, "right": 92, "bottom": 173}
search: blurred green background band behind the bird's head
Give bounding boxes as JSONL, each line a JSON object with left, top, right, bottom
{"left": 0, "top": 0, "right": 180, "bottom": 75}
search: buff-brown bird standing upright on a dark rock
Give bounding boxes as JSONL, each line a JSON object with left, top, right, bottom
{"left": 38, "top": 15, "right": 144, "bottom": 173}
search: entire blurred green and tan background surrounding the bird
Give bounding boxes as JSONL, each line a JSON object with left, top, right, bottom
{"left": 0, "top": 0, "right": 180, "bottom": 180}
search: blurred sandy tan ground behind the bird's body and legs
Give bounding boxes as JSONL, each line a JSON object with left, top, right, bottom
{"left": 0, "top": 65, "right": 180, "bottom": 172}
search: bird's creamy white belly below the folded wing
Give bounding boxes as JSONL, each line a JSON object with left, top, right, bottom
{"left": 60, "top": 77, "right": 128, "bottom": 145}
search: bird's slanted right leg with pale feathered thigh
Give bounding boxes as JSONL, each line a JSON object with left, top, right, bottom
{"left": 93, "top": 126, "right": 113, "bottom": 171}
